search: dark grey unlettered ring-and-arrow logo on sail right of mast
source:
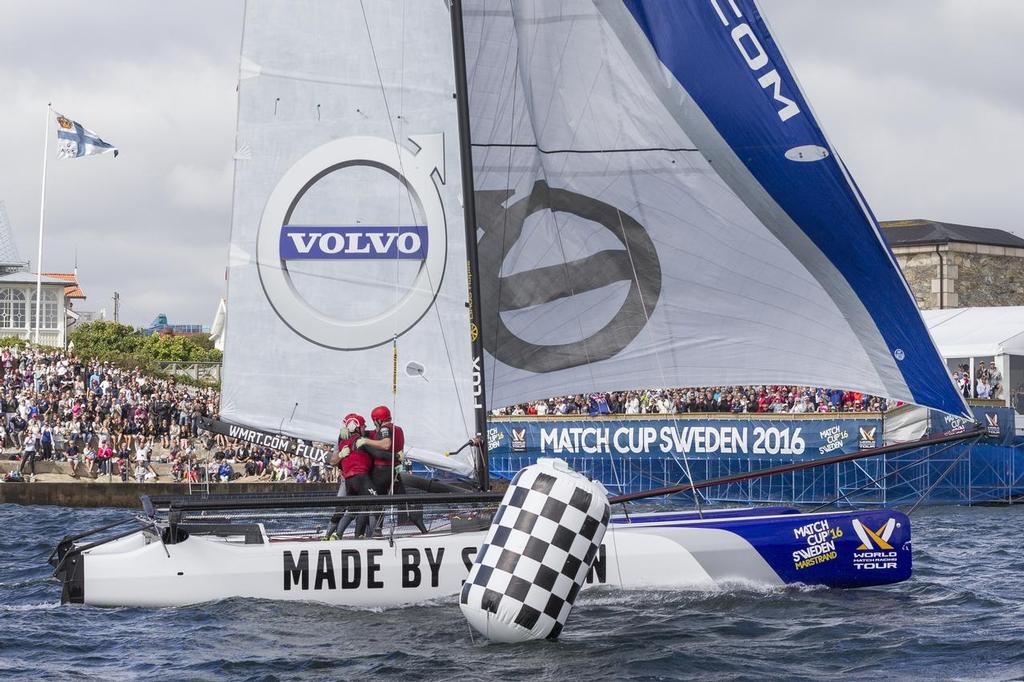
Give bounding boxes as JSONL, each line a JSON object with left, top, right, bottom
{"left": 475, "top": 180, "right": 662, "bottom": 373}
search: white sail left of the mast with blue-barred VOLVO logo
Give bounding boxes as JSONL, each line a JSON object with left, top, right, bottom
{"left": 221, "top": 0, "right": 474, "bottom": 473}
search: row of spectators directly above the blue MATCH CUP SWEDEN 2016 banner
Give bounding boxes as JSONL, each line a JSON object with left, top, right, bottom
{"left": 494, "top": 385, "right": 886, "bottom": 417}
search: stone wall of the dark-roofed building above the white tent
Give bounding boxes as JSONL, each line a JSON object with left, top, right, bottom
{"left": 893, "top": 242, "right": 1024, "bottom": 309}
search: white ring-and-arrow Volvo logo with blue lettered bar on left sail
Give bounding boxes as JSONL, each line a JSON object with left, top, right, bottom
{"left": 256, "top": 134, "right": 447, "bottom": 350}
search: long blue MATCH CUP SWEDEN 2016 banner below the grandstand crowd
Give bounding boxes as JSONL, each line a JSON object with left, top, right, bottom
{"left": 487, "top": 418, "right": 882, "bottom": 458}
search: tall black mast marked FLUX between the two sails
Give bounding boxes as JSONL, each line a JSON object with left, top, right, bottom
{"left": 451, "top": 0, "right": 490, "bottom": 491}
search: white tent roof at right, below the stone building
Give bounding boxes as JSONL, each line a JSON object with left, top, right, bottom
{"left": 922, "top": 305, "right": 1024, "bottom": 358}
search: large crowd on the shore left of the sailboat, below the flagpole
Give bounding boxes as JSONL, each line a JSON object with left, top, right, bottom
{"left": 0, "top": 346, "right": 332, "bottom": 483}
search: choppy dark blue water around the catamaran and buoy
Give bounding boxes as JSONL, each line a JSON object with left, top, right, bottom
{"left": 0, "top": 505, "right": 1024, "bottom": 680}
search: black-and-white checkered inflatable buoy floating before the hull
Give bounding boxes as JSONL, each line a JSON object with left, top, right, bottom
{"left": 460, "top": 459, "right": 611, "bottom": 642}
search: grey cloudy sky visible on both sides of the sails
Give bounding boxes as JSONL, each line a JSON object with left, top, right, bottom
{"left": 0, "top": 0, "right": 1024, "bottom": 325}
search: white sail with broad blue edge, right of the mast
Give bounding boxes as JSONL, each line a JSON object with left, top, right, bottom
{"left": 466, "top": 0, "right": 968, "bottom": 415}
